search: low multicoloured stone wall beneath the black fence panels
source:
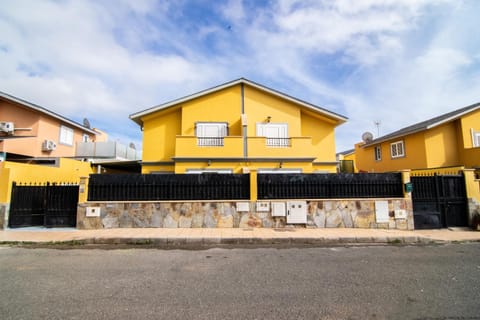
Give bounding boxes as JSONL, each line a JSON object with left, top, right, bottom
{"left": 77, "top": 199, "right": 414, "bottom": 230}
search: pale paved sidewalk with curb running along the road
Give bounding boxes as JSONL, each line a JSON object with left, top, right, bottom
{"left": 0, "top": 228, "right": 480, "bottom": 248}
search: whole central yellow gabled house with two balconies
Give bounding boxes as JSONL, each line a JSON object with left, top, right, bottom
{"left": 130, "top": 78, "right": 347, "bottom": 173}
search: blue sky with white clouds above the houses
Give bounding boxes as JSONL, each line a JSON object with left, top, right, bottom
{"left": 0, "top": 0, "right": 480, "bottom": 152}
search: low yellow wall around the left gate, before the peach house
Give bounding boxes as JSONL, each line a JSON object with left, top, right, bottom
{"left": 0, "top": 158, "right": 94, "bottom": 203}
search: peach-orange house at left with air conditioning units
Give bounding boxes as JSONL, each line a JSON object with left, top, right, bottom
{"left": 0, "top": 92, "right": 100, "bottom": 162}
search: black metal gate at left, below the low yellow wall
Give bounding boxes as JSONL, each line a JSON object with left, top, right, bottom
{"left": 8, "top": 182, "right": 78, "bottom": 228}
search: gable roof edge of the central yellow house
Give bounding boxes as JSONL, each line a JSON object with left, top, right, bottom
{"left": 130, "top": 78, "right": 348, "bottom": 126}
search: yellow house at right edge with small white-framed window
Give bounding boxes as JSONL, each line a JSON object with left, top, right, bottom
{"left": 355, "top": 103, "right": 480, "bottom": 172}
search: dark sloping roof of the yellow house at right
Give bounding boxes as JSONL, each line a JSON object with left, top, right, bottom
{"left": 362, "top": 103, "right": 480, "bottom": 147}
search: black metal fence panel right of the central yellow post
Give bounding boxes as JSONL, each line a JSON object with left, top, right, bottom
{"left": 257, "top": 173, "right": 403, "bottom": 199}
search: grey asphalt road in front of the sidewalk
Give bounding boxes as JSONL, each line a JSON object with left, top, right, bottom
{"left": 0, "top": 243, "right": 480, "bottom": 319}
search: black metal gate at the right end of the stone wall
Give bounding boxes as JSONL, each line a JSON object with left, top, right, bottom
{"left": 411, "top": 174, "right": 468, "bottom": 229}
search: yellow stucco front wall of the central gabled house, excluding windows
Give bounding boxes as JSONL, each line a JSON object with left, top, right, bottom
{"left": 141, "top": 84, "right": 338, "bottom": 173}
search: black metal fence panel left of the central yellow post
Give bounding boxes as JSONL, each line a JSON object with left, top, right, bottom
{"left": 88, "top": 173, "right": 250, "bottom": 201}
